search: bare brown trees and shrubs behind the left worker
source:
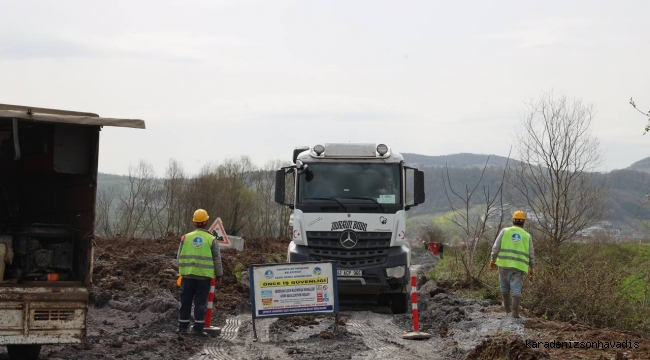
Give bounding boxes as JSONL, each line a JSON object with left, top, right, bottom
{"left": 96, "top": 157, "right": 290, "bottom": 238}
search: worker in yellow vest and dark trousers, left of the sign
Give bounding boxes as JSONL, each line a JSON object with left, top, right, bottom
{"left": 178, "top": 209, "right": 223, "bottom": 336}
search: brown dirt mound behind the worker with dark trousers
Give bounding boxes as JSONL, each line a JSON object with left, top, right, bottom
{"left": 90, "top": 237, "right": 288, "bottom": 314}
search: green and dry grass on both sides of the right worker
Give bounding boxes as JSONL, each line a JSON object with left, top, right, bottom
{"left": 436, "top": 242, "right": 650, "bottom": 334}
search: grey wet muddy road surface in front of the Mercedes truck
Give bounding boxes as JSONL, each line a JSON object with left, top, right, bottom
{"left": 181, "top": 283, "right": 532, "bottom": 360}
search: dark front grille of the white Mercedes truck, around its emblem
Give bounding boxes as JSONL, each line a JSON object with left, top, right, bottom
{"left": 307, "top": 231, "right": 392, "bottom": 268}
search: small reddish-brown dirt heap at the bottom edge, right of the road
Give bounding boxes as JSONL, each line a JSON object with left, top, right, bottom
{"left": 463, "top": 338, "right": 550, "bottom": 360}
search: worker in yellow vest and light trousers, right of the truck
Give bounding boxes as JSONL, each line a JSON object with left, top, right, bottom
{"left": 490, "top": 210, "right": 535, "bottom": 318}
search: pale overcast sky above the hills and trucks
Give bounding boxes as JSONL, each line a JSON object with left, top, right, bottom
{"left": 0, "top": 0, "right": 650, "bottom": 175}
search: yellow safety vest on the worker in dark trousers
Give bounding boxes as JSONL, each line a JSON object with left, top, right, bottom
{"left": 178, "top": 230, "right": 215, "bottom": 278}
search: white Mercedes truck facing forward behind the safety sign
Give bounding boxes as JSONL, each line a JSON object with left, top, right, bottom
{"left": 275, "top": 144, "right": 425, "bottom": 314}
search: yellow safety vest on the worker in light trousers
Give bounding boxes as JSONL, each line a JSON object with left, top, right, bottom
{"left": 496, "top": 226, "right": 530, "bottom": 273}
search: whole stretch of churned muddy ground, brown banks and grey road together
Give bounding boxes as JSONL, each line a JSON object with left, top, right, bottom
{"left": 0, "top": 238, "right": 650, "bottom": 360}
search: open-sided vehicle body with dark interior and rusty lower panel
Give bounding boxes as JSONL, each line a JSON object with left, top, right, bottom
{"left": 0, "top": 104, "right": 144, "bottom": 359}
